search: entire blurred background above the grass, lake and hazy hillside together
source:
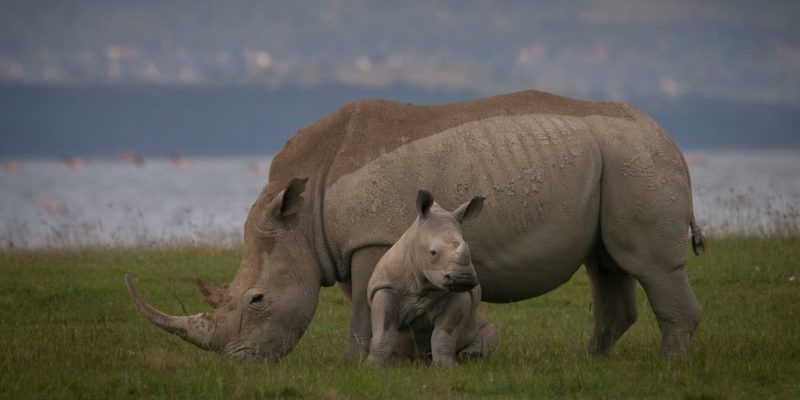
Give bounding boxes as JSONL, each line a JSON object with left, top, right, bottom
{"left": 0, "top": 0, "right": 800, "bottom": 247}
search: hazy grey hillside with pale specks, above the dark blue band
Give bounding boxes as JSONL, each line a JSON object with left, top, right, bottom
{"left": 0, "top": 0, "right": 800, "bottom": 103}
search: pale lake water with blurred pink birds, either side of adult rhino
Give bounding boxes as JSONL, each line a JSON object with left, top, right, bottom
{"left": 0, "top": 152, "right": 800, "bottom": 248}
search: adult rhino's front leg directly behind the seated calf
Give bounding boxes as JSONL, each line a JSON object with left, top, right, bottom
{"left": 345, "top": 246, "right": 389, "bottom": 361}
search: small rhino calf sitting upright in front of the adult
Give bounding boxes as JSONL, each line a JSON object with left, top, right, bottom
{"left": 367, "top": 190, "right": 497, "bottom": 366}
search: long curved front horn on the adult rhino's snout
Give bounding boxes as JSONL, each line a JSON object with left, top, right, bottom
{"left": 125, "top": 275, "right": 214, "bottom": 350}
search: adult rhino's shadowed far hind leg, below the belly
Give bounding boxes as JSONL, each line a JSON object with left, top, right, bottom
{"left": 586, "top": 249, "right": 638, "bottom": 354}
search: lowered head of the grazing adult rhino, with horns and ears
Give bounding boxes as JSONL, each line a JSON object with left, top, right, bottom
{"left": 125, "top": 179, "right": 321, "bottom": 360}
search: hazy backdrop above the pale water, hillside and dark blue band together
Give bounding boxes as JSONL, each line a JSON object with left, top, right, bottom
{"left": 0, "top": 0, "right": 800, "bottom": 157}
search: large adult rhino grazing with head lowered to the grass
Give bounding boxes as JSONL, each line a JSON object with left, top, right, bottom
{"left": 126, "top": 91, "right": 703, "bottom": 359}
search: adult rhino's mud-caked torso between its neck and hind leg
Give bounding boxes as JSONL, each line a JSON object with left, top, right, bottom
{"left": 323, "top": 92, "right": 632, "bottom": 301}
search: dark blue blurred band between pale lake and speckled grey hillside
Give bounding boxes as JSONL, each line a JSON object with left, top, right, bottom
{"left": 0, "top": 84, "right": 800, "bottom": 159}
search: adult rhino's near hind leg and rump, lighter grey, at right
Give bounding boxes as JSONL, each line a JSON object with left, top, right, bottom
{"left": 598, "top": 115, "right": 702, "bottom": 357}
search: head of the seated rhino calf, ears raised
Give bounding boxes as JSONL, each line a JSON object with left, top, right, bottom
{"left": 411, "top": 190, "right": 484, "bottom": 292}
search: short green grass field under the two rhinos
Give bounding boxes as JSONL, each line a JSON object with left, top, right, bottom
{"left": 0, "top": 238, "right": 800, "bottom": 399}
